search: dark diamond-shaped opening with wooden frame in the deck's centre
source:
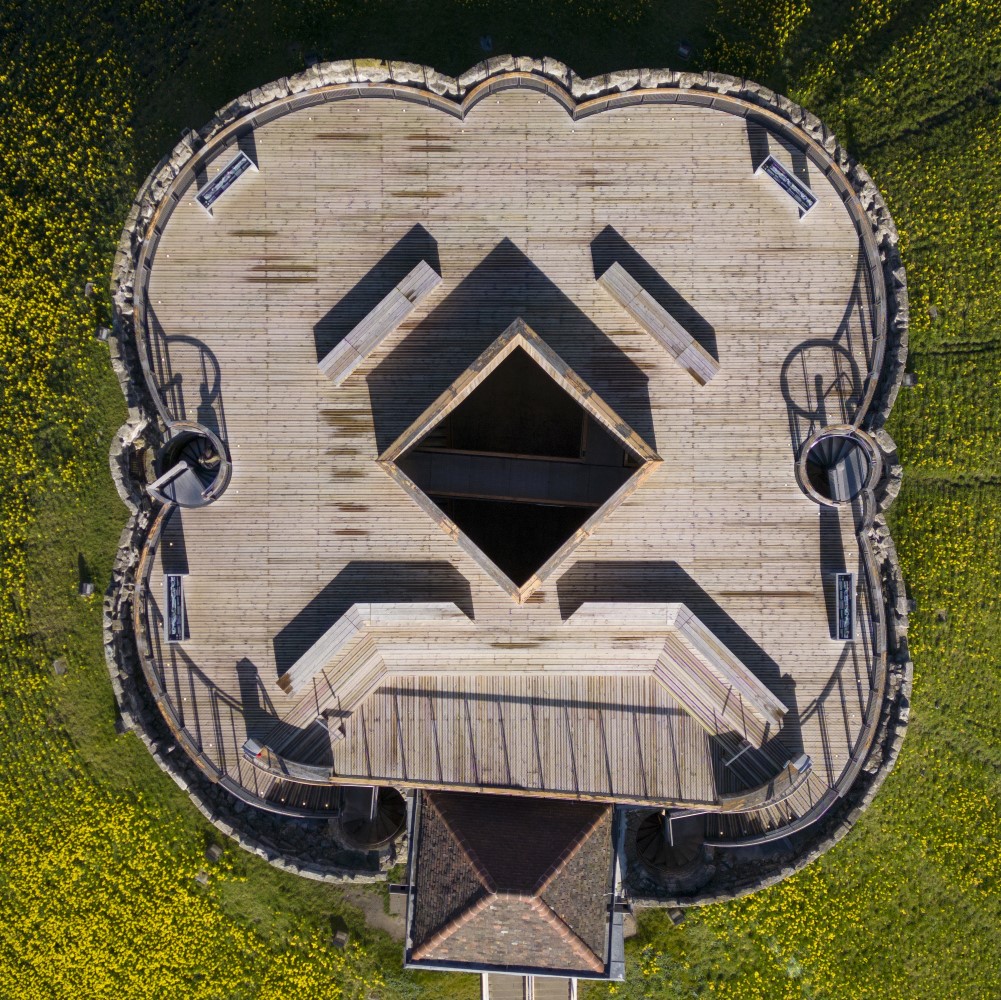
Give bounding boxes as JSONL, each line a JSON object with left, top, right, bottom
{"left": 380, "top": 320, "right": 660, "bottom": 601}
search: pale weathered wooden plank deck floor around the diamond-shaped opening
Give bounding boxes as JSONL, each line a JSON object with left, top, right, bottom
{"left": 139, "top": 84, "right": 871, "bottom": 801}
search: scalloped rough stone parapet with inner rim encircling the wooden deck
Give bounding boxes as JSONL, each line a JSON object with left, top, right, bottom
{"left": 104, "top": 55, "right": 912, "bottom": 906}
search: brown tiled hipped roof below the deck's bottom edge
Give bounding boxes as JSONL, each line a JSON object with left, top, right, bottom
{"left": 410, "top": 793, "right": 612, "bottom": 972}
